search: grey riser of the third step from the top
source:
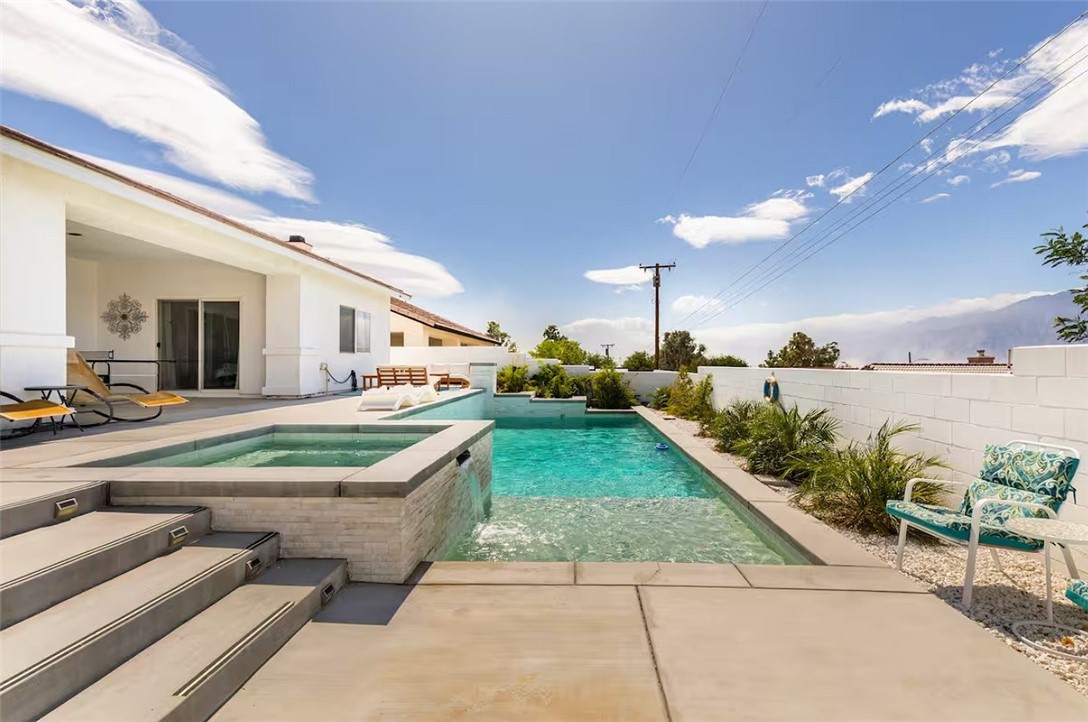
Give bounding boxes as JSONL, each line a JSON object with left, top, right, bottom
{"left": 0, "top": 536, "right": 280, "bottom": 722}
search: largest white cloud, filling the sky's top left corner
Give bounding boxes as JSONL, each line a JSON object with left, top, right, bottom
{"left": 0, "top": 0, "right": 312, "bottom": 200}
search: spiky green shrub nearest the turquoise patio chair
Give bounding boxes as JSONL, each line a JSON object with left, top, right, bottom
{"left": 792, "top": 421, "right": 945, "bottom": 533}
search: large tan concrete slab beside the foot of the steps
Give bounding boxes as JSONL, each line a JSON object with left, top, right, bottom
{"left": 212, "top": 586, "right": 667, "bottom": 722}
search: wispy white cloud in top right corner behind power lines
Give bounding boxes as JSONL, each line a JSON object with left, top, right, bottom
{"left": 874, "top": 18, "right": 1088, "bottom": 160}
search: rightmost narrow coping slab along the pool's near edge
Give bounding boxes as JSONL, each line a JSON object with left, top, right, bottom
{"left": 737, "top": 564, "right": 927, "bottom": 594}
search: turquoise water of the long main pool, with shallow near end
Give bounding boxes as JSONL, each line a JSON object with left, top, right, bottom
{"left": 443, "top": 414, "right": 802, "bottom": 564}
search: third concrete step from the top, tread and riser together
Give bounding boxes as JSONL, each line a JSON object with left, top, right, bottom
{"left": 0, "top": 533, "right": 280, "bottom": 722}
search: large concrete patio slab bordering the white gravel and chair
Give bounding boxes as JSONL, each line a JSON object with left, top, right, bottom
{"left": 641, "top": 587, "right": 1086, "bottom": 722}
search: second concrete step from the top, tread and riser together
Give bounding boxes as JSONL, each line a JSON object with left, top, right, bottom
{"left": 0, "top": 507, "right": 211, "bottom": 628}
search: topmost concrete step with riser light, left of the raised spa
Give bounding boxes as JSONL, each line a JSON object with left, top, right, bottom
{"left": 0, "top": 482, "right": 110, "bottom": 539}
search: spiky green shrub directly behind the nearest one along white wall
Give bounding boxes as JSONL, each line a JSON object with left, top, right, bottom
{"left": 733, "top": 403, "right": 839, "bottom": 482}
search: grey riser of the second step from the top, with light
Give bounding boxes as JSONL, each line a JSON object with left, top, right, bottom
{"left": 0, "top": 509, "right": 211, "bottom": 628}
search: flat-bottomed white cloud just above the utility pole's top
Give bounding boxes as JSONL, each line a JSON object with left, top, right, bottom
{"left": 657, "top": 190, "right": 812, "bottom": 248}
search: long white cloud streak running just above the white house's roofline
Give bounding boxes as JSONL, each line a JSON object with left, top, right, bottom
{"left": 81, "top": 153, "right": 465, "bottom": 296}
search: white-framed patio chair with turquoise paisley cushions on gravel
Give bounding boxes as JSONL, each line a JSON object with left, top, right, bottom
{"left": 887, "top": 439, "right": 1080, "bottom": 609}
